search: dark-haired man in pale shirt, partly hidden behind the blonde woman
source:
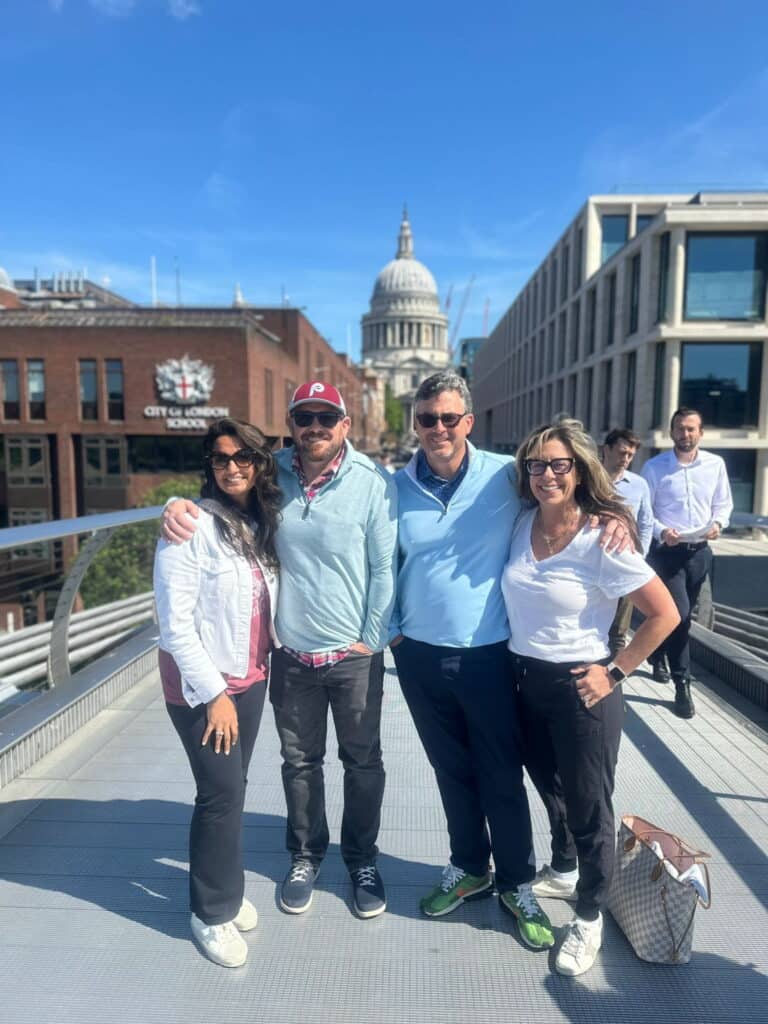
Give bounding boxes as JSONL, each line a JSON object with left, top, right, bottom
{"left": 603, "top": 430, "right": 653, "bottom": 656}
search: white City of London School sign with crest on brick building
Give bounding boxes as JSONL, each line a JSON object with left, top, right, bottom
{"left": 144, "top": 355, "right": 229, "bottom": 430}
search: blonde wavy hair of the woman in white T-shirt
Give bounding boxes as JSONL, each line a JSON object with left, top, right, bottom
{"left": 515, "top": 419, "right": 640, "bottom": 551}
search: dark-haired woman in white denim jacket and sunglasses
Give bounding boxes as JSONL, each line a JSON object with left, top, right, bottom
{"left": 155, "top": 419, "right": 281, "bottom": 967}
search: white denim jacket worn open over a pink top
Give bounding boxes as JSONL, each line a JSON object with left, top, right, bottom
{"left": 155, "top": 509, "right": 281, "bottom": 708}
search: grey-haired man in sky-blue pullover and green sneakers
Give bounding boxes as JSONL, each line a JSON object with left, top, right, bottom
{"left": 390, "top": 371, "right": 554, "bottom": 949}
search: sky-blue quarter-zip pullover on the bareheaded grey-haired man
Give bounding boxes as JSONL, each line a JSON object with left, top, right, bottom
{"left": 391, "top": 441, "right": 520, "bottom": 647}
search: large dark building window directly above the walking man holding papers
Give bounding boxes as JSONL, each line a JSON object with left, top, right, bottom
{"left": 678, "top": 342, "right": 763, "bottom": 428}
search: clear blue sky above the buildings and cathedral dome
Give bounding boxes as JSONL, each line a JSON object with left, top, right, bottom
{"left": 0, "top": 0, "right": 768, "bottom": 356}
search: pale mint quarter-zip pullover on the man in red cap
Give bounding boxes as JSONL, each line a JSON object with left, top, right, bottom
{"left": 275, "top": 441, "right": 397, "bottom": 652}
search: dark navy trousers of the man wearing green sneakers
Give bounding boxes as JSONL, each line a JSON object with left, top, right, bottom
{"left": 392, "top": 637, "right": 536, "bottom": 892}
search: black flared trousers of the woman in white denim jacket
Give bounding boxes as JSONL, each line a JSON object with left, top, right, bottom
{"left": 166, "top": 683, "right": 266, "bottom": 925}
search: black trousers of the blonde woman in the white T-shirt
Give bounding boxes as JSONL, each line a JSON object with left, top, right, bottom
{"left": 512, "top": 655, "right": 624, "bottom": 921}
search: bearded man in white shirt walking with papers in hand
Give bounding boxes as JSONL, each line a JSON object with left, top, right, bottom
{"left": 642, "top": 408, "right": 733, "bottom": 718}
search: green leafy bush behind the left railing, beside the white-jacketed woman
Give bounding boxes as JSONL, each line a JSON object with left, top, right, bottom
{"left": 80, "top": 476, "right": 200, "bottom": 608}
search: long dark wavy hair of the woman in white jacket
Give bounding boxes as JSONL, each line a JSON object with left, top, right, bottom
{"left": 200, "top": 417, "right": 282, "bottom": 569}
